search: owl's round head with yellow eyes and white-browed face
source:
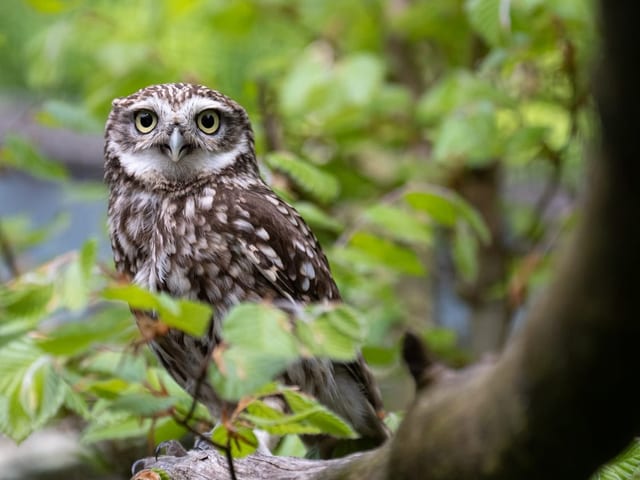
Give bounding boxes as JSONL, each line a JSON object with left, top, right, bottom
{"left": 105, "top": 83, "right": 257, "bottom": 187}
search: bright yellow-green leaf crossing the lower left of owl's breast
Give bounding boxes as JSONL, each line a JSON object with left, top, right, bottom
{"left": 102, "top": 284, "right": 212, "bottom": 337}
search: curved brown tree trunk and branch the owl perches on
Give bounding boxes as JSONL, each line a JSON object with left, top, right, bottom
{"left": 131, "top": 0, "right": 640, "bottom": 480}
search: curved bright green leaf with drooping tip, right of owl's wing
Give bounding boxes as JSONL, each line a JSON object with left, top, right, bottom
{"left": 405, "top": 187, "right": 491, "bottom": 243}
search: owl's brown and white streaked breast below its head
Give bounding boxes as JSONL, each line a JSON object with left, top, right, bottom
{"left": 110, "top": 187, "right": 261, "bottom": 317}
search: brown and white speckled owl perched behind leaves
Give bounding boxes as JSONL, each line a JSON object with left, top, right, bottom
{"left": 105, "top": 83, "right": 388, "bottom": 456}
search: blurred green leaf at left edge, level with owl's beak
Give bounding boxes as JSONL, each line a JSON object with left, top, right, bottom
{"left": 0, "top": 133, "right": 68, "bottom": 180}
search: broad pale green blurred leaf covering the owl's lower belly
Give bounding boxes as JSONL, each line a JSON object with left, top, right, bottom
{"left": 209, "top": 303, "right": 298, "bottom": 400}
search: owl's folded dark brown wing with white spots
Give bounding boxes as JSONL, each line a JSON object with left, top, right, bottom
{"left": 227, "top": 186, "right": 340, "bottom": 302}
